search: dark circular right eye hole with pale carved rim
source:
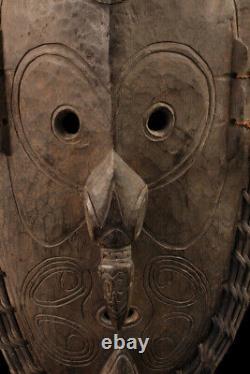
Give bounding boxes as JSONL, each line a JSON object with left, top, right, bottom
{"left": 145, "top": 103, "right": 175, "bottom": 140}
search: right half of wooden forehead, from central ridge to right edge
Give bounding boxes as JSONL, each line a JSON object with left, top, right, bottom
{"left": 110, "top": 0, "right": 237, "bottom": 76}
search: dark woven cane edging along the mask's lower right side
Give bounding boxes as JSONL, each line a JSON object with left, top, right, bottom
{"left": 182, "top": 188, "right": 250, "bottom": 374}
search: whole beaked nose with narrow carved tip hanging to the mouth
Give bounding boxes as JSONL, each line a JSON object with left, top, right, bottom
{"left": 84, "top": 151, "right": 148, "bottom": 329}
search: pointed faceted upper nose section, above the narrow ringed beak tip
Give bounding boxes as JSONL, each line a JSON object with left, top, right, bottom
{"left": 85, "top": 151, "right": 148, "bottom": 249}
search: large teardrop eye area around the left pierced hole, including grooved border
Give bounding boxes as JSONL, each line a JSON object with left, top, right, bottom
{"left": 12, "top": 44, "right": 112, "bottom": 189}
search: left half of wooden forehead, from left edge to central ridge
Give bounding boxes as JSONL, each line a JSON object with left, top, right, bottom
{"left": 2, "top": 0, "right": 110, "bottom": 86}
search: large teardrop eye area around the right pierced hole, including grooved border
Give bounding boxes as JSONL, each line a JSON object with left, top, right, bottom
{"left": 116, "top": 43, "right": 215, "bottom": 188}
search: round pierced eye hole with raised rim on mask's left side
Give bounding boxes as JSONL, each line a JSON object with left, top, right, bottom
{"left": 51, "top": 105, "right": 82, "bottom": 144}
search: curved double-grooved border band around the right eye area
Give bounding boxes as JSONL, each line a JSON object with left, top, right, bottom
{"left": 116, "top": 42, "right": 216, "bottom": 190}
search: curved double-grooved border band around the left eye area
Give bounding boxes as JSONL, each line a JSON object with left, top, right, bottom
{"left": 10, "top": 43, "right": 108, "bottom": 191}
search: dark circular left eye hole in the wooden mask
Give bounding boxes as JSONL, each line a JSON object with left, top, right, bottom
{"left": 52, "top": 108, "right": 81, "bottom": 140}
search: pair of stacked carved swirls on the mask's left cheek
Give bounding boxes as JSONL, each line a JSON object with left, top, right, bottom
{"left": 21, "top": 257, "right": 98, "bottom": 367}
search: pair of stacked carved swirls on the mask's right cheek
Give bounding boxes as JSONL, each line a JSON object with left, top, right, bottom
{"left": 143, "top": 255, "right": 210, "bottom": 369}
